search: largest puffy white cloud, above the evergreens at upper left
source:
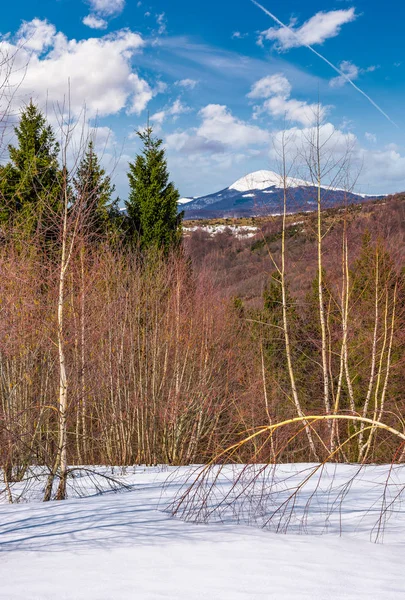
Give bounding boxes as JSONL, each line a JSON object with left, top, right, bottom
{"left": 0, "top": 19, "right": 154, "bottom": 118}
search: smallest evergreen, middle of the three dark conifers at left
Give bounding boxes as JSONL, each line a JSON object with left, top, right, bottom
{"left": 73, "top": 141, "right": 118, "bottom": 235}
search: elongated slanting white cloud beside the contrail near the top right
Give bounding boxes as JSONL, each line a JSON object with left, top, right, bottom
{"left": 260, "top": 8, "right": 357, "bottom": 51}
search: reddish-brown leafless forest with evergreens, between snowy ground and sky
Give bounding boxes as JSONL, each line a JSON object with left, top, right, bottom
{"left": 0, "top": 54, "right": 405, "bottom": 500}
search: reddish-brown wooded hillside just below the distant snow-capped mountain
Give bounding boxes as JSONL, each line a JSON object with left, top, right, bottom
{"left": 184, "top": 194, "right": 405, "bottom": 303}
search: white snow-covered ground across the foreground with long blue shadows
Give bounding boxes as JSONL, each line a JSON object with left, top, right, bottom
{"left": 0, "top": 465, "right": 405, "bottom": 600}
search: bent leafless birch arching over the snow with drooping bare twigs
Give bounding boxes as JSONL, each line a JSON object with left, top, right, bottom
{"left": 171, "top": 415, "right": 405, "bottom": 541}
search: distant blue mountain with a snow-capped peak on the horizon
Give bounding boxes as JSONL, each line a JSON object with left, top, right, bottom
{"left": 182, "top": 170, "right": 380, "bottom": 219}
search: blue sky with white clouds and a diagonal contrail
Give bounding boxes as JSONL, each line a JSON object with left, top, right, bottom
{"left": 0, "top": 0, "right": 405, "bottom": 200}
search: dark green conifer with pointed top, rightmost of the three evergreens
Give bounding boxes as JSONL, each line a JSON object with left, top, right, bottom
{"left": 126, "top": 126, "right": 183, "bottom": 252}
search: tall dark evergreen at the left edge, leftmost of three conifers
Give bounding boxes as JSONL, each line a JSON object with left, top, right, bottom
{"left": 0, "top": 101, "right": 61, "bottom": 233}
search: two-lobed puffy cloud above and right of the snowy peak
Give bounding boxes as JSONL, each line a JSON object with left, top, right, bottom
{"left": 247, "top": 73, "right": 327, "bottom": 126}
